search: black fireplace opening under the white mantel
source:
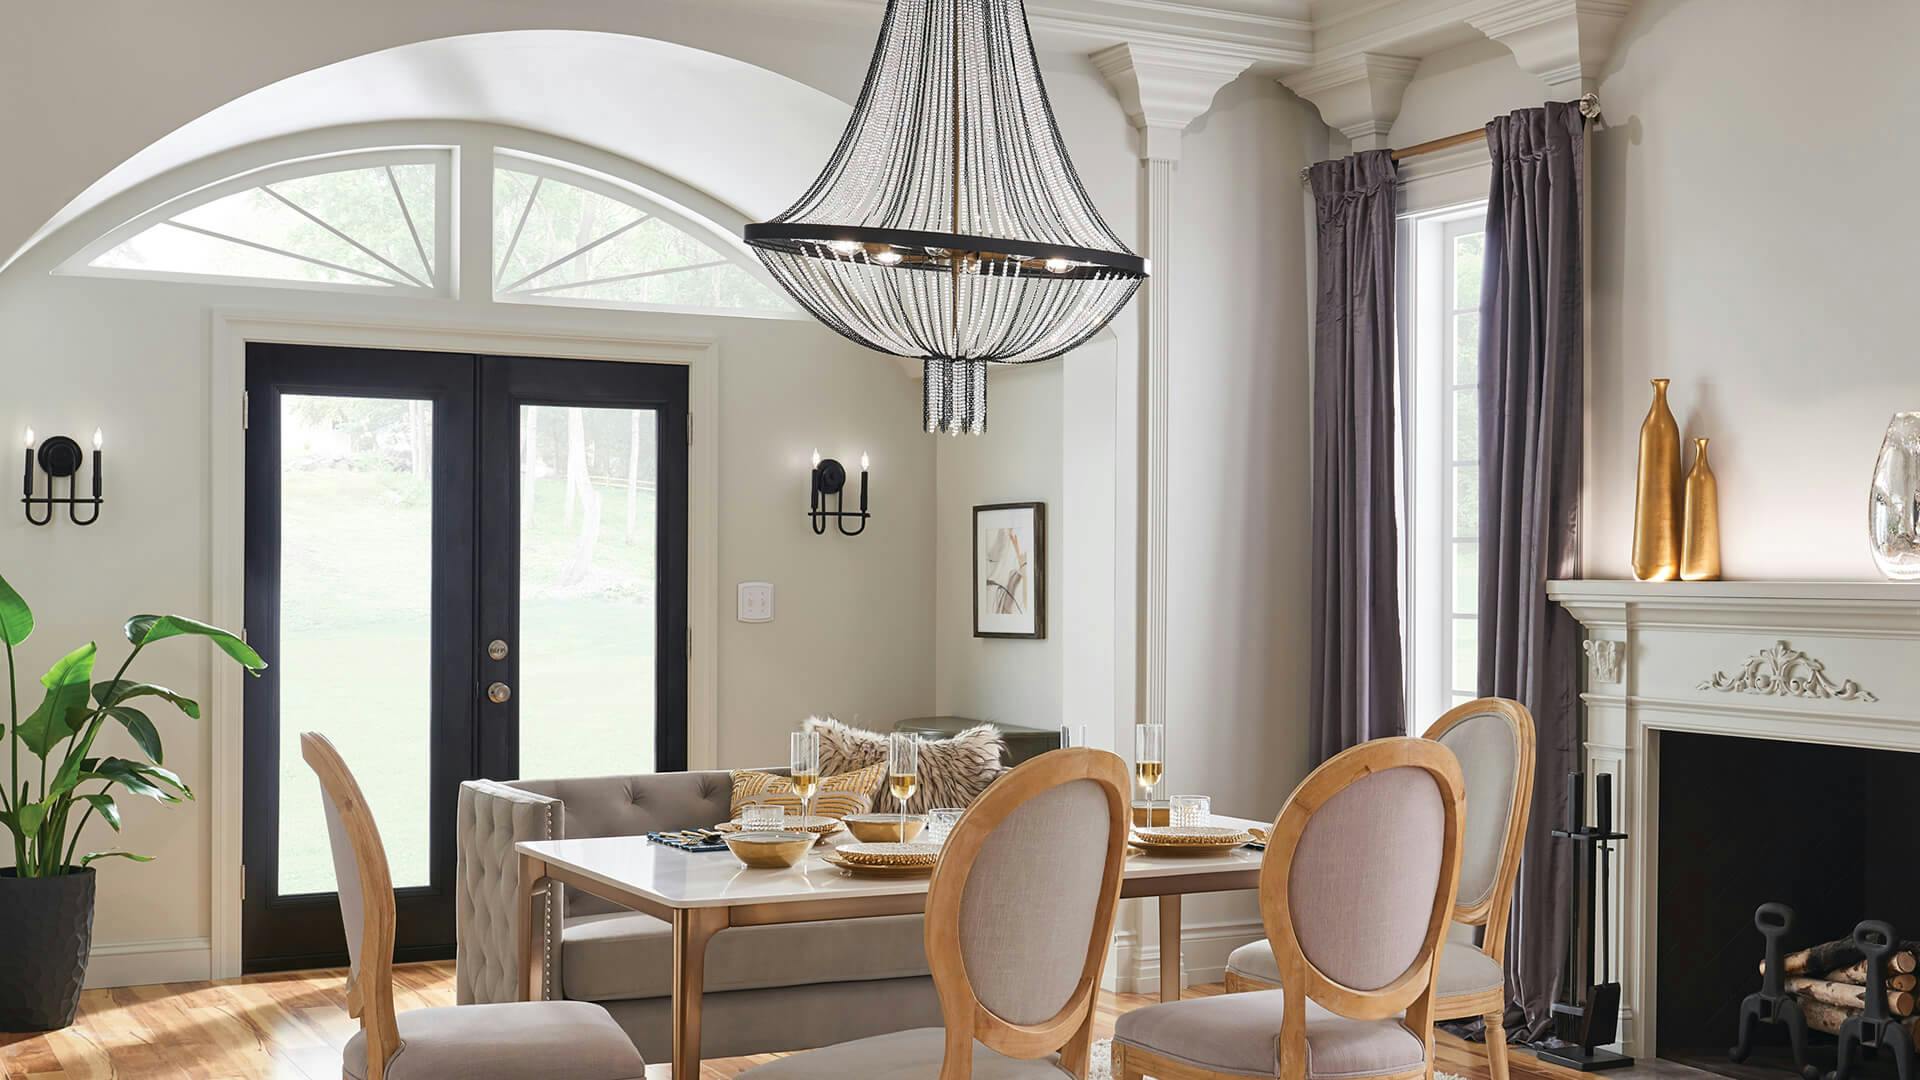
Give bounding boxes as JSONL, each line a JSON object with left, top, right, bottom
{"left": 1655, "top": 732, "right": 1920, "bottom": 1080}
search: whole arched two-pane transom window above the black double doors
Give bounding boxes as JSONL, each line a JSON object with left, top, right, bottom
{"left": 61, "top": 148, "right": 797, "bottom": 315}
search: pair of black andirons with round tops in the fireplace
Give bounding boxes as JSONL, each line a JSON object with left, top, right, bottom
{"left": 1726, "top": 903, "right": 1916, "bottom": 1080}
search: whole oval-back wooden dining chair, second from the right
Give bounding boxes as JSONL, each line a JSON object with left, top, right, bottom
{"left": 1114, "top": 738, "right": 1465, "bottom": 1080}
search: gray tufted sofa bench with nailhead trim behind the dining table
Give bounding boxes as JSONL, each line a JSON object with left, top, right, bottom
{"left": 455, "top": 771, "right": 941, "bottom": 1061}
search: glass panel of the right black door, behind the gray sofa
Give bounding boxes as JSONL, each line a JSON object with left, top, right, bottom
{"left": 515, "top": 405, "right": 660, "bottom": 776}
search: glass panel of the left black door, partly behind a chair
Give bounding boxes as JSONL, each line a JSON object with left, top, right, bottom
{"left": 275, "top": 394, "right": 434, "bottom": 896}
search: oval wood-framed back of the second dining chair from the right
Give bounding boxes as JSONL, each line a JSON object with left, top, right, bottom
{"left": 1260, "top": 738, "right": 1465, "bottom": 1080}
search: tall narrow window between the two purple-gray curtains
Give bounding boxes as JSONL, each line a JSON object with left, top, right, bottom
{"left": 1402, "top": 204, "right": 1486, "bottom": 721}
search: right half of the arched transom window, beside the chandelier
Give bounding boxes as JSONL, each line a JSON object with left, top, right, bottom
{"left": 493, "top": 156, "right": 793, "bottom": 311}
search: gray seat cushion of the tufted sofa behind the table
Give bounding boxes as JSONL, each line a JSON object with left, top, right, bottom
{"left": 561, "top": 911, "right": 927, "bottom": 1001}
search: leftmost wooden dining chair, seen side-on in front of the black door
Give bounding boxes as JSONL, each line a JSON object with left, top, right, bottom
{"left": 300, "top": 732, "right": 647, "bottom": 1080}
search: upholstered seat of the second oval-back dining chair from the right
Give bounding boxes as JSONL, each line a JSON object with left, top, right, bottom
{"left": 1114, "top": 990, "right": 1427, "bottom": 1080}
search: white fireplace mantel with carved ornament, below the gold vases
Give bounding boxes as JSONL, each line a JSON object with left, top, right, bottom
{"left": 1548, "top": 580, "right": 1920, "bottom": 1057}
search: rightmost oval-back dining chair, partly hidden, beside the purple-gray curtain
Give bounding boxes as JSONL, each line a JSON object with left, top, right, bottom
{"left": 1227, "top": 698, "right": 1534, "bottom": 1080}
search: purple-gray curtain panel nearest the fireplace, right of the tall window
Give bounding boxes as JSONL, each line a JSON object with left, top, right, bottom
{"left": 1480, "top": 102, "right": 1586, "bottom": 1040}
